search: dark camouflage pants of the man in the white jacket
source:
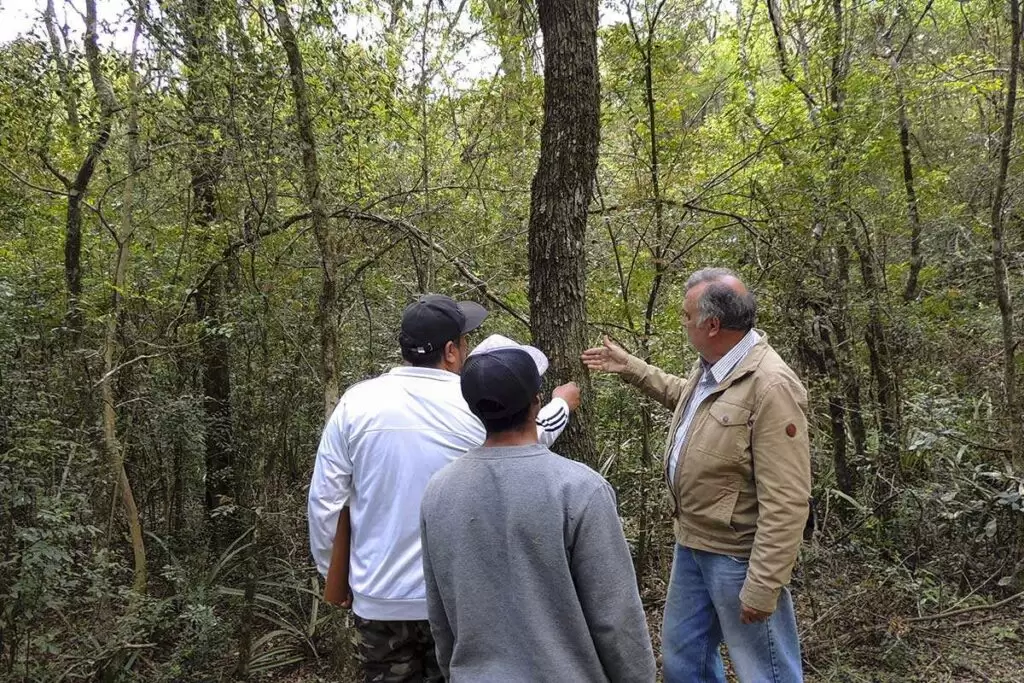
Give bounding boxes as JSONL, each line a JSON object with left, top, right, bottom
{"left": 352, "top": 614, "right": 444, "bottom": 683}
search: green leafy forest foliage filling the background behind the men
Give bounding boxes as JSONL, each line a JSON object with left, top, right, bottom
{"left": 0, "top": 0, "right": 1024, "bottom": 681}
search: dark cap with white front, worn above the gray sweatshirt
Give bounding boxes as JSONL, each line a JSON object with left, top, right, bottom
{"left": 461, "top": 335, "right": 548, "bottom": 420}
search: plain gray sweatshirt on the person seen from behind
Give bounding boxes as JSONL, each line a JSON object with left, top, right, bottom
{"left": 420, "top": 445, "right": 654, "bottom": 683}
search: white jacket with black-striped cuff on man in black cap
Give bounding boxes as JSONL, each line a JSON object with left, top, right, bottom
{"left": 308, "top": 367, "right": 569, "bottom": 621}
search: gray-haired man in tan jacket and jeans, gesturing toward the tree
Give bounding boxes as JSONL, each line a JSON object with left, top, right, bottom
{"left": 583, "top": 268, "right": 811, "bottom": 683}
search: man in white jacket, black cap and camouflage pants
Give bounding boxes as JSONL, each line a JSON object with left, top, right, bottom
{"left": 308, "top": 295, "right": 580, "bottom": 683}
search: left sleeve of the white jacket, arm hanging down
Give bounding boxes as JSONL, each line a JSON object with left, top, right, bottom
{"left": 307, "top": 398, "right": 352, "bottom": 577}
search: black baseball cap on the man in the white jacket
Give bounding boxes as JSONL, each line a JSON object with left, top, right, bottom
{"left": 398, "top": 294, "right": 487, "bottom": 355}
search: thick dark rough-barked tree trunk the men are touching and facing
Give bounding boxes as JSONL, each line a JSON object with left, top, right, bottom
{"left": 529, "top": 0, "right": 600, "bottom": 464}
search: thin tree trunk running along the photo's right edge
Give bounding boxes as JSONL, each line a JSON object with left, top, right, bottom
{"left": 992, "top": 0, "right": 1024, "bottom": 461}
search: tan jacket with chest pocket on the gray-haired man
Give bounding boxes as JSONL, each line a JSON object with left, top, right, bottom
{"left": 623, "top": 333, "right": 811, "bottom": 612}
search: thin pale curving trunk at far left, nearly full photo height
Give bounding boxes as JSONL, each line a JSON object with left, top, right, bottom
{"left": 99, "top": 10, "right": 146, "bottom": 595}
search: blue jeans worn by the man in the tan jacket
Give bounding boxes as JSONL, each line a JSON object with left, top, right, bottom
{"left": 662, "top": 544, "right": 804, "bottom": 683}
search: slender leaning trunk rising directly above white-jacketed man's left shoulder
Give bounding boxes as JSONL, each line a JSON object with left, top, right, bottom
{"left": 273, "top": 0, "right": 341, "bottom": 421}
